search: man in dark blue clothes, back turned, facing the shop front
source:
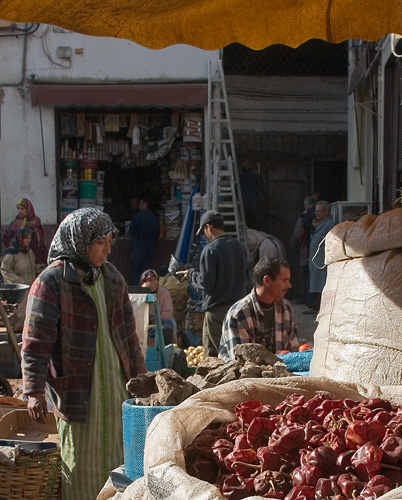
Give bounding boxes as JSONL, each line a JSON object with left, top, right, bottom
{"left": 129, "top": 198, "right": 160, "bottom": 285}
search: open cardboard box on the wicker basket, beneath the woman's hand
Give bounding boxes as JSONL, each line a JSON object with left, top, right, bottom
{"left": 0, "top": 409, "right": 59, "bottom": 443}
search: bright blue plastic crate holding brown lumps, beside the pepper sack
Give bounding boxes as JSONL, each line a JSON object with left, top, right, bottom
{"left": 123, "top": 399, "right": 174, "bottom": 481}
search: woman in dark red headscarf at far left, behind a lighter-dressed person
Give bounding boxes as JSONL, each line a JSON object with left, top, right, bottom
{"left": 3, "top": 198, "right": 47, "bottom": 266}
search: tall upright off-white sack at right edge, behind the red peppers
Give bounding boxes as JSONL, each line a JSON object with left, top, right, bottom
{"left": 310, "top": 208, "right": 402, "bottom": 385}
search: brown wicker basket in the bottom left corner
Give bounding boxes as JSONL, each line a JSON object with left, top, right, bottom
{"left": 0, "top": 448, "right": 61, "bottom": 500}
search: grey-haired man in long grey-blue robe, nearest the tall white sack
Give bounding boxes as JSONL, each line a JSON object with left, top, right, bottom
{"left": 309, "top": 201, "right": 335, "bottom": 312}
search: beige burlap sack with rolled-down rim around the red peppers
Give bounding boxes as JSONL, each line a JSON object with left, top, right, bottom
{"left": 104, "top": 377, "right": 402, "bottom": 500}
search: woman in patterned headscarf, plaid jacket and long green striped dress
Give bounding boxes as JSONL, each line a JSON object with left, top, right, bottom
{"left": 22, "top": 208, "right": 147, "bottom": 500}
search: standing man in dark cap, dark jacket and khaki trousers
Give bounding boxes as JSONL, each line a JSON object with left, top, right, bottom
{"left": 177, "top": 210, "right": 246, "bottom": 357}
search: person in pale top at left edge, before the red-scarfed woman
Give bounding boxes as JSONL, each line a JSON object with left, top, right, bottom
{"left": 1, "top": 227, "right": 37, "bottom": 286}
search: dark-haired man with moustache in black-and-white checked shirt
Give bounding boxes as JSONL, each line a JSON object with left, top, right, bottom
{"left": 218, "top": 257, "right": 299, "bottom": 362}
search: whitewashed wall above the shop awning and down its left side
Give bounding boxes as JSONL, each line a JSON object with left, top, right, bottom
{"left": 0, "top": 25, "right": 219, "bottom": 224}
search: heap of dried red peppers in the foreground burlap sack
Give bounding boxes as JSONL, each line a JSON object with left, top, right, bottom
{"left": 185, "top": 394, "right": 402, "bottom": 500}
